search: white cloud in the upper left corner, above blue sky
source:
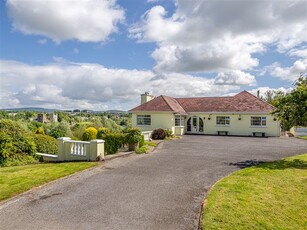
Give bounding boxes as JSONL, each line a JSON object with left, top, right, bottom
{"left": 7, "top": 0, "right": 125, "bottom": 43}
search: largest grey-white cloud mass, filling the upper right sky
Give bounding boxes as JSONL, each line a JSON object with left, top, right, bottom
{"left": 130, "top": 0, "right": 307, "bottom": 73}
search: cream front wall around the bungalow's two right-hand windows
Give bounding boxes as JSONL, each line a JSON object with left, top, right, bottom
{"left": 185, "top": 113, "right": 280, "bottom": 136}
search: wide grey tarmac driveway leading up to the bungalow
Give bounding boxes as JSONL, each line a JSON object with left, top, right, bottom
{"left": 0, "top": 136, "right": 307, "bottom": 230}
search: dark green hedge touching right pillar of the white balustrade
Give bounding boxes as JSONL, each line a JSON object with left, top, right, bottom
{"left": 102, "top": 133, "right": 126, "bottom": 154}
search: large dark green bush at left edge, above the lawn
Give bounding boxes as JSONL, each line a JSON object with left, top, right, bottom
{"left": 0, "top": 120, "right": 37, "bottom": 164}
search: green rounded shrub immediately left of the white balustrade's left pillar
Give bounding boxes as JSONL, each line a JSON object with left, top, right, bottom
{"left": 33, "top": 134, "right": 58, "bottom": 155}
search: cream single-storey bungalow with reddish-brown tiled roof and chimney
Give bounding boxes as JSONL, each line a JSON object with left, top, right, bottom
{"left": 129, "top": 91, "right": 280, "bottom": 136}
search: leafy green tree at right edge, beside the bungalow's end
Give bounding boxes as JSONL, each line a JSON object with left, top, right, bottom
{"left": 271, "top": 73, "right": 307, "bottom": 130}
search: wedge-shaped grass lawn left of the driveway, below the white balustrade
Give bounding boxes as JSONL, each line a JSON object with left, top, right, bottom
{"left": 0, "top": 162, "right": 98, "bottom": 201}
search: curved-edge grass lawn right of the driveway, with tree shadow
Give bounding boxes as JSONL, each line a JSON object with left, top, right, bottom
{"left": 202, "top": 154, "right": 307, "bottom": 230}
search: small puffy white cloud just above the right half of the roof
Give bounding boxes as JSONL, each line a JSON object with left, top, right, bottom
{"left": 215, "top": 70, "right": 256, "bottom": 86}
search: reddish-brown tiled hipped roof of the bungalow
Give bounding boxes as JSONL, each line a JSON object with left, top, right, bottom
{"left": 130, "top": 91, "right": 274, "bottom": 114}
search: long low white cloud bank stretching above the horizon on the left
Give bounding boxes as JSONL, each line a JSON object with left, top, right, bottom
{"left": 0, "top": 58, "right": 240, "bottom": 110}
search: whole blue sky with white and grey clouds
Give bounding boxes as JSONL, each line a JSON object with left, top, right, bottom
{"left": 0, "top": 0, "right": 307, "bottom": 111}
